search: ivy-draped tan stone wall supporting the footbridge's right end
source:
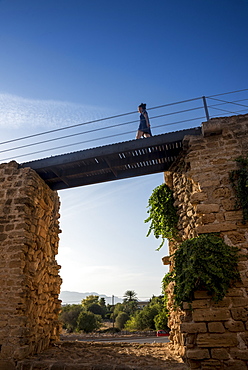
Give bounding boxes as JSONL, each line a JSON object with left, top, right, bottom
{"left": 165, "top": 115, "right": 248, "bottom": 370}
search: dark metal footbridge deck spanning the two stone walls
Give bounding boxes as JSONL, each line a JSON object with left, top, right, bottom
{"left": 20, "top": 127, "right": 201, "bottom": 190}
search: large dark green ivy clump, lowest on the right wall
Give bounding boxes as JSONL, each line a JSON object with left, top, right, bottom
{"left": 163, "top": 234, "right": 240, "bottom": 307}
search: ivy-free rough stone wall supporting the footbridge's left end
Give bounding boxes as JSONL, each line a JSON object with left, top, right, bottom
{"left": 0, "top": 162, "right": 61, "bottom": 370}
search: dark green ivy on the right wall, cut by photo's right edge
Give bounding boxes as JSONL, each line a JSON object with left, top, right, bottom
{"left": 230, "top": 157, "right": 248, "bottom": 224}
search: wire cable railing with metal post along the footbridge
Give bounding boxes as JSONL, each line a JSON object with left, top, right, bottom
{"left": 0, "top": 89, "right": 248, "bottom": 162}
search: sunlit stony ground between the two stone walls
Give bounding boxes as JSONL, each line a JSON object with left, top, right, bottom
{"left": 17, "top": 341, "right": 188, "bottom": 370}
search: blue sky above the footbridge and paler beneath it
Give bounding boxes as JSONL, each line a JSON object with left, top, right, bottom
{"left": 0, "top": 0, "right": 248, "bottom": 297}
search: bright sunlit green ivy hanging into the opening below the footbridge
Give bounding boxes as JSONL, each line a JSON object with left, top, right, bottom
{"left": 145, "top": 184, "right": 178, "bottom": 250}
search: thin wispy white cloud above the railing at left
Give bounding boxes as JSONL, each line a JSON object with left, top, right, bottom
{"left": 0, "top": 93, "right": 108, "bottom": 128}
